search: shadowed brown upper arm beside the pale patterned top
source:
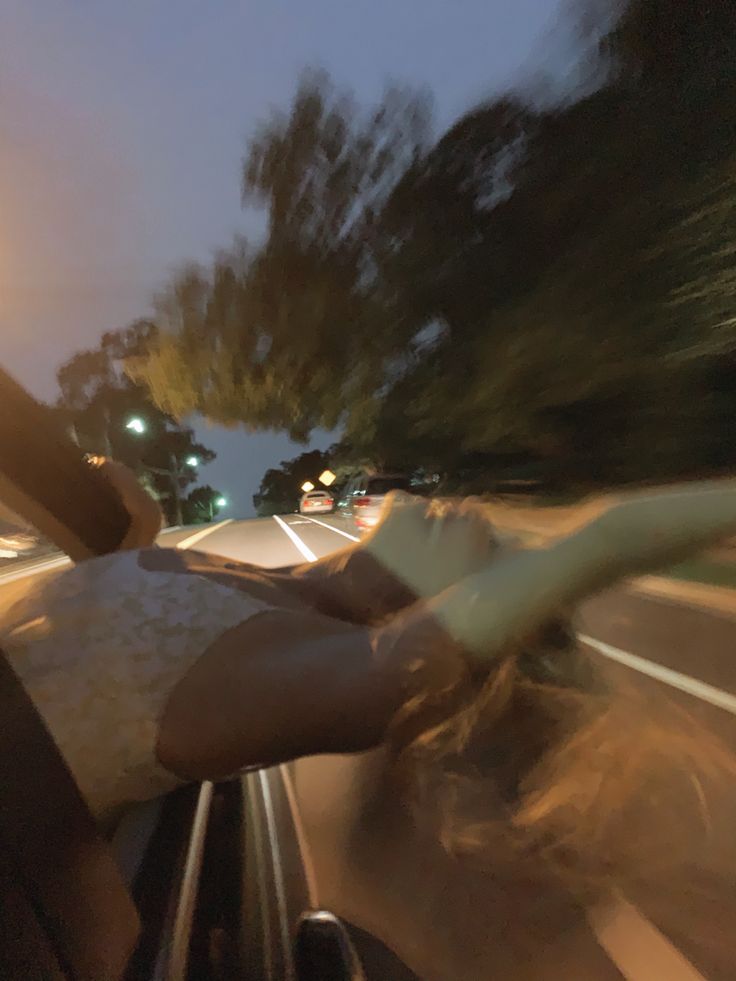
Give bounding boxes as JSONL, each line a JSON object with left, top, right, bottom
{"left": 157, "top": 609, "right": 468, "bottom": 780}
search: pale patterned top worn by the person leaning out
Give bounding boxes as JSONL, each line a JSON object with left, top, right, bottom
{"left": 0, "top": 552, "right": 269, "bottom": 818}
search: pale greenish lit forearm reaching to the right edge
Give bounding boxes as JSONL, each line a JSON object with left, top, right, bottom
{"left": 429, "top": 480, "right": 736, "bottom": 657}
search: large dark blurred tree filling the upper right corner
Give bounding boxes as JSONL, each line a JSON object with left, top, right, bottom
{"left": 376, "top": 0, "right": 736, "bottom": 486}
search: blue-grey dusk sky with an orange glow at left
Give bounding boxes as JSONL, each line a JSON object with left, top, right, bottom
{"left": 0, "top": 0, "right": 566, "bottom": 516}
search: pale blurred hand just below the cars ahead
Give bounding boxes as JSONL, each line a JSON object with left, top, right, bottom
{"left": 360, "top": 491, "right": 499, "bottom": 599}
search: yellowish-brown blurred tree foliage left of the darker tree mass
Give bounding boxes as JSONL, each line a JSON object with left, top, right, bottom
{"left": 130, "top": 73, "right": 429, "bottom": 441}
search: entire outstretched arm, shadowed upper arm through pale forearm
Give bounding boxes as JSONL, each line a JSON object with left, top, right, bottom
{"left": 159, "top": 474, "right": 736, "bottom": 778}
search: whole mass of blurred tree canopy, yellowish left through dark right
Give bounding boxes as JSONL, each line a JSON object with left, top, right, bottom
{"left": 130, "top": 0, "right": 736, "bottom": 487}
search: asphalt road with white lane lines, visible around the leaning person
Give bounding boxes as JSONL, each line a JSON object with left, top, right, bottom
{"left": 0, "top": 514, "right": 736, "bottom": 981}
